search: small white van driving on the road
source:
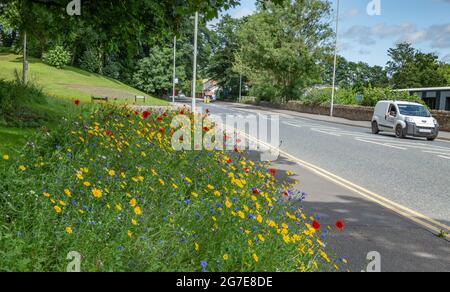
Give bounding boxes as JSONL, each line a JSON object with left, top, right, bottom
{"left": 372, "top": 101, "right": 439, "bottom": 141}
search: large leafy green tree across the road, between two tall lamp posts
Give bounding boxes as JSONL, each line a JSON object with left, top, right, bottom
{"left": 234, "top": 0, "right": 332, "bottom": 100}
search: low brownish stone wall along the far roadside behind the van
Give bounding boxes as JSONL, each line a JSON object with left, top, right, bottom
{"left": 261, "top": 101, "right": 450, "bottom": 131}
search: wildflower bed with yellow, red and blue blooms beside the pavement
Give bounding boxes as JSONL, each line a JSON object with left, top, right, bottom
{"left": 0, "top": 101, "right": 344, "bottom": 272}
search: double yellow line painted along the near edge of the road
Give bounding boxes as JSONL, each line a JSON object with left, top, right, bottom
{"left": 239, "top": 131, "right": 450, "bottom": 240}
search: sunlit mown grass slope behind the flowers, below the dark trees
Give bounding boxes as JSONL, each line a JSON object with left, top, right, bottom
{"left": 0, "top": 53, "right": 167, "bottom": 105}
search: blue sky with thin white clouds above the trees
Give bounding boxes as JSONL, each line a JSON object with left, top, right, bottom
{"left": 214, "top": 0, "right": 450, "bottom": 66}
